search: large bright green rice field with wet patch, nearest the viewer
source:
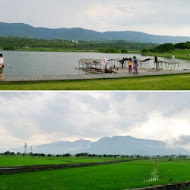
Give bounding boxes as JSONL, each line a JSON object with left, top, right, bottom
{"left": 0, "top": 160, "right": 190, "bottom": 190}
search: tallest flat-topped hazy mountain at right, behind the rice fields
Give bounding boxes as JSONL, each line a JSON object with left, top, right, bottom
{"left": 89, "top": 137, "right": 189, "bottom": 155}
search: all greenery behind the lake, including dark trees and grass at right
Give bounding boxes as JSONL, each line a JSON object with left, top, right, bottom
{"left": 0, "top": 37, "right": 190, "bottom": 59}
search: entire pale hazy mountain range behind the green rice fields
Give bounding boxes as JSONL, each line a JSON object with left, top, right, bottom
{"left": 4, "top": 136, "right": 190, "bottom": 156}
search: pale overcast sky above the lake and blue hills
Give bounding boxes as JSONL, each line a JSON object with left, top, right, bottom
{"left": 0, "top": 0, "right": 190, "bottom": 36}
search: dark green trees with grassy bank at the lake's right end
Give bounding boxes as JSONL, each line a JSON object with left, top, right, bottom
{"left": 142, "top": 42, "right": 190, "bottom": 59}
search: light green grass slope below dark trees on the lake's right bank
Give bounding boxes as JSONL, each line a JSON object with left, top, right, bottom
{"left": 143, "top": 49, "right": 190, "bottom": 59}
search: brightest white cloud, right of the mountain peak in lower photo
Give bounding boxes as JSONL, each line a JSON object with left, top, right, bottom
{"left": 128, "top": 112, "right": 190, "bottom": 143}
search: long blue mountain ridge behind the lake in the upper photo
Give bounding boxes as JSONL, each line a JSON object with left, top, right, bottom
{"left": 0, "top": 22, "right": 190, "bottom": 44}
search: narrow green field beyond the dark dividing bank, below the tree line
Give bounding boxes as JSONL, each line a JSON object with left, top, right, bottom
{"left": 0, "top": 156, "right": 116, "bottom": 167}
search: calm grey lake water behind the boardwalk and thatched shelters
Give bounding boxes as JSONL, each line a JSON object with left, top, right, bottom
{"left": 1, "top": 51, "right": 190, "bottom": 76}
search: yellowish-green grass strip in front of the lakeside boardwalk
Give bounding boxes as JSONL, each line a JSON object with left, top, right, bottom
{"left": 0, "top": 74, "right": 190, "bottom": 90}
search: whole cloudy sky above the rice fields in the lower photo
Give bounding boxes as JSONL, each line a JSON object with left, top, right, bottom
{"left": 0, "top": 92, "right": 190, "bottom": 150}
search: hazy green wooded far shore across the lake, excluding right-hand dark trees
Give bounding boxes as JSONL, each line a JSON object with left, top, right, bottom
{"left": 0, "top": 37, "right": 157, "bottom": 53}
